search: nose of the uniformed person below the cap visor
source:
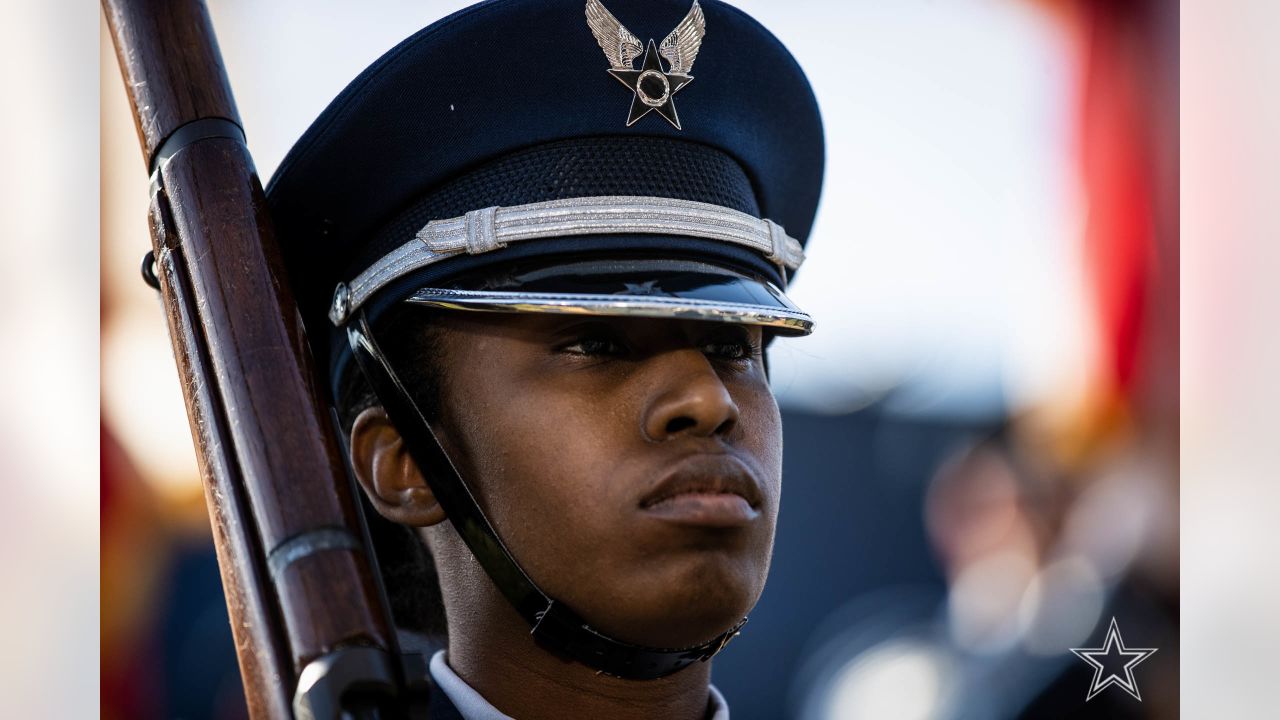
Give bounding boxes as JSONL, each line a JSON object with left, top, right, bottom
{"left": 643, "top": 348, "right": 737, "bottom": 442}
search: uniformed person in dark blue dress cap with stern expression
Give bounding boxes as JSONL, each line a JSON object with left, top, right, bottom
{"left": 268, "top": 0, "right": 823, "bottom": 719}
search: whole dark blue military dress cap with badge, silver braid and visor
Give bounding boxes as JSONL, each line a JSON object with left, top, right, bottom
{"left": 266, "top": 0, "right": 823, "bottom": 386}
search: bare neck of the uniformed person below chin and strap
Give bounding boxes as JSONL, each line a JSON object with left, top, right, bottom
{"left": 448, "top": 597, "right": 710, "bottom": 720}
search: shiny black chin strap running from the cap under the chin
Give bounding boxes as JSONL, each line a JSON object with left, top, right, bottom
{"left": 347, "top": 313, "right": 746, "bottom": 680}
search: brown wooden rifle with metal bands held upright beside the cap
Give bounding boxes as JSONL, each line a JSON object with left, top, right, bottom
{"left": 102, "top": 0, "right": 422, "bottom": 719}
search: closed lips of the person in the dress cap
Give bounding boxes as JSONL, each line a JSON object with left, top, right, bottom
{"left": 640, "top": 454, "right": 763, "bottom": 527}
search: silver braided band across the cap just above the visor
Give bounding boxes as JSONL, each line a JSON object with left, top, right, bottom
{"left": 329, "top": 195, "right": 804, "bottom": 327}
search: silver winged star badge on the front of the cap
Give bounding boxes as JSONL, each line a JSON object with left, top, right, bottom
{"left": 586, "top": 0, "right": 707, "bottom": 129}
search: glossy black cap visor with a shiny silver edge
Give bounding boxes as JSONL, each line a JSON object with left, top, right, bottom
{"left": 404, "top": 259, "right": 813, "bottom": 336}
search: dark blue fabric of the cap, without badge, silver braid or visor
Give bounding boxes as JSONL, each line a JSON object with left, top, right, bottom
{"left": 268, "top": 0, "right": 823, "bottom": 386}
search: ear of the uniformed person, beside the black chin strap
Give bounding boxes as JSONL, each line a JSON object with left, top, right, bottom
{"left": 351, "top": 405, "right": 444, "bottom": 528}
